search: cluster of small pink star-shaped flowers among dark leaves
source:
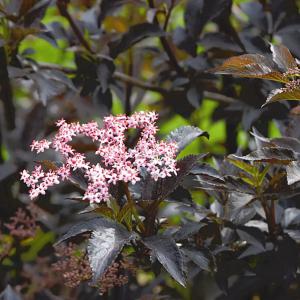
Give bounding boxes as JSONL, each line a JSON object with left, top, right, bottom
{"left": 21, "top": 112, "right": 177, "bottom": 203}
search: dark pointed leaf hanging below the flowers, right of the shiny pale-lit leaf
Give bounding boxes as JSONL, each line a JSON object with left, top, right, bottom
{"left": 143, "top": 235, "right": 186, "bottom": 286}
